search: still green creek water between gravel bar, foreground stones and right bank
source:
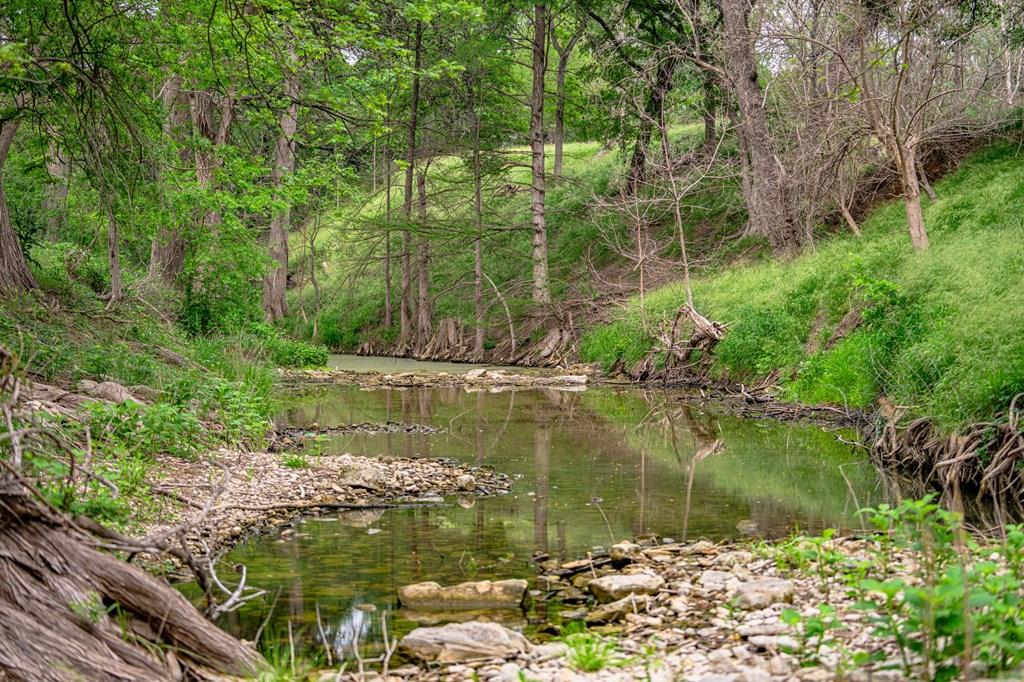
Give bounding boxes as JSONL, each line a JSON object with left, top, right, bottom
{"left": 205, "top": 366, "right": 882, "bottom": 655}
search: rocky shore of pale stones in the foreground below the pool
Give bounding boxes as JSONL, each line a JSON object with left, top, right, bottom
{"left": 319, "top": 538, "right": 929, "bottom": 682}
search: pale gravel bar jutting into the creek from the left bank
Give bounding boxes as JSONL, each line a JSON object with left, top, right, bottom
{"left": 144, "top": 451, "right": 510, "bottom": 552}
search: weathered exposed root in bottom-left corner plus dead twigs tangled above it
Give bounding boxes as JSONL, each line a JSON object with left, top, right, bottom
{"left": 0, "top": 347, "right": 266, "bottom": 681}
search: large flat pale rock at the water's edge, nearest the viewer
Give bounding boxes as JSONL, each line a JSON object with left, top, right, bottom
{"left": 398, "top": 622, "right": 532, "bottom": 663}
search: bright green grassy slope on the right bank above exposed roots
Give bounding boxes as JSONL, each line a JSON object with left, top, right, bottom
{"left": 583, "top": 143, "right": 1024, "bottom": 430}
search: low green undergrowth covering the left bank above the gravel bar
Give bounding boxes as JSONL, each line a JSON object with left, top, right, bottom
{"left": 0, "top": 266, "right": 327, "bottom": 526}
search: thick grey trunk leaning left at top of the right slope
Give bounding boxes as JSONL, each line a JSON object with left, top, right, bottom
{"left": 721, "top": 0, "right": 800, "bottom": 253}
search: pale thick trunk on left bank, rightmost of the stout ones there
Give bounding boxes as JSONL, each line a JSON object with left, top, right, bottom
{"left": 263, "top": 53, "right": 299, "bottom": 323}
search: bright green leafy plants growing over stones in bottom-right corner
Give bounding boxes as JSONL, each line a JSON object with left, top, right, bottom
{"left": 768, "top": 497, "right": 1024, "bottom": 680}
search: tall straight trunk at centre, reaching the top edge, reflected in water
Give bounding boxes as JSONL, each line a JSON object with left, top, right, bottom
{"left": 529, "top": 4, "right": 551, "bottom": 305}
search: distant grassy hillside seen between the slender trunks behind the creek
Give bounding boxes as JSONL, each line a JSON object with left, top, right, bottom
{"left": 290, "top": 125, "right": 750, "bottom": 350}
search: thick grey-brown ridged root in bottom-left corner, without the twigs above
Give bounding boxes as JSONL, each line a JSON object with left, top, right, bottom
{"left": 0, "top": 491, "right": 265, "bottom": 680}
